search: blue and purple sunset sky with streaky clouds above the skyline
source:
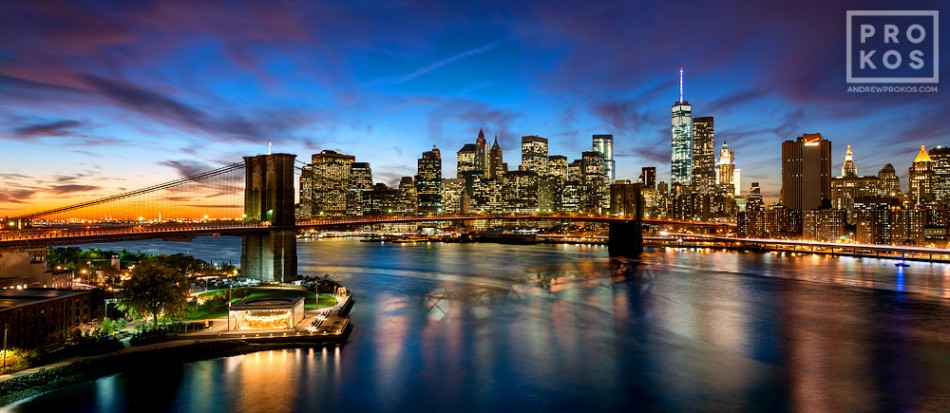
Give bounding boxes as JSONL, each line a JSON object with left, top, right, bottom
{"left": 0, "top": 0, "right": 950, "bottom": 216}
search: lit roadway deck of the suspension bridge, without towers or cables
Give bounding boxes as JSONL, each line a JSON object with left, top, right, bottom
{"left": 0, "top": 214, "right": 734, "bottom": 248}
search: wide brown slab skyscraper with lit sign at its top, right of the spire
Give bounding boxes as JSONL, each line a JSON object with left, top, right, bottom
{"left": 782, "top": 133, "right": 831, "bottom": 211}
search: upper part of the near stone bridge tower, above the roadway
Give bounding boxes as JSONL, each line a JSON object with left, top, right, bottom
{"left": 244, "top": 153, "right": 297, "bottom": 228}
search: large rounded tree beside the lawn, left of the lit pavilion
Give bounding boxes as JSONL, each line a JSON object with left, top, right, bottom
{"left": 122, "top": 257, "right": 188, "bottom": 328}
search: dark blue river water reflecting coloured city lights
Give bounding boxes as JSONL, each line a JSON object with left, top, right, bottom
{"left": 6, "top": 238, "right": 950, "bottom": 413}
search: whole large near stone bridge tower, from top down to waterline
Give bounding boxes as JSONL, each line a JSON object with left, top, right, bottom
{"left": 241, "top": 153, "right": 297, "bottom": 282}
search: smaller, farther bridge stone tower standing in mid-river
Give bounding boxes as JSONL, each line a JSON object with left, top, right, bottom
{"left": 607, "top": 183, "right": 643, "bottom": 258}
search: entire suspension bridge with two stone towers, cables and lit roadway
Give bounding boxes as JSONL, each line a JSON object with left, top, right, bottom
{"left": 0, "top": 154, "right": 734, "bottom": 255}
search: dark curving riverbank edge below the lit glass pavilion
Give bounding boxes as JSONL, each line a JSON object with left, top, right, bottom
{"left": 0, "top": 296, "right": 354, "bottom": 406}
